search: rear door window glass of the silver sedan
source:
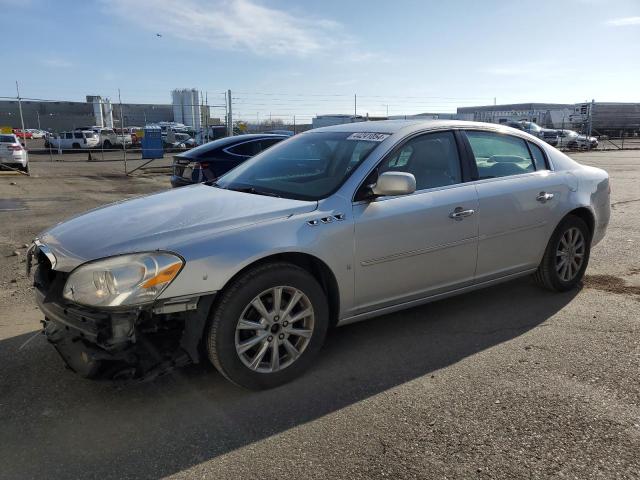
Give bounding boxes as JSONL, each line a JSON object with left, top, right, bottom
{"left": 465, "top": 131, "right": 535, "bottom": 180}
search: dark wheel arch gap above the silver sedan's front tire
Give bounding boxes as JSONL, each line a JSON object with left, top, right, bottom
{"left": 218, "top": 252, "right": 340, "bottom": 327}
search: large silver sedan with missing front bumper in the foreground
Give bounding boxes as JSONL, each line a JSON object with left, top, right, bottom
{"left": 27, "top": 121, "right": 610, "bottom": 389}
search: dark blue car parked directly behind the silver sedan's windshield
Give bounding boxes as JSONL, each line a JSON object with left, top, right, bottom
{"left": 171, "top": 134, "right": 289, "bottom": 187}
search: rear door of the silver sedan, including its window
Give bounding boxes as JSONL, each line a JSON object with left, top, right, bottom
{"left": 466, "top": 131, "right": 569, "bottom": 282}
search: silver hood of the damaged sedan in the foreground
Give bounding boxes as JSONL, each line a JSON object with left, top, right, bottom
{"left": 38, "top": 184, "right": 317, "bottom": 271}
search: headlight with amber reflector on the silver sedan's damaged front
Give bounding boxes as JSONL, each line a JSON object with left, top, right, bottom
{"left": 63, "top": 252, "right": 184, "bottom": 307}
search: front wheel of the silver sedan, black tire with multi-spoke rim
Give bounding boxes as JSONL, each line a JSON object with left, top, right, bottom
{"left": 205, "top": 262, "right": 329, "bottom": 390}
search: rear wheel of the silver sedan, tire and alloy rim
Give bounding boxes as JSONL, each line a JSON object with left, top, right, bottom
{"left": 534, "top": 215, "right": 591, "bottom": 292}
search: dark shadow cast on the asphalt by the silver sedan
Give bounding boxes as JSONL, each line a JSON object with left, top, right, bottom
{"left": 0, "top": 279, "right": 577, "bottom": 478}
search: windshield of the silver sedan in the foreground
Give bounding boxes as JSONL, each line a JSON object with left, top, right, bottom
{"left": 215, "top": 132, "right": 388, "bottom": 200}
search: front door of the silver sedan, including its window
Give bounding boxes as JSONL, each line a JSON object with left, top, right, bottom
{"left": 353, "top": 131, "right": 478, "bottom": 313}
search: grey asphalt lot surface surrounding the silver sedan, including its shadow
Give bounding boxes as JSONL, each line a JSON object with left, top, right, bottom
{"left": 0, "top": 151, "right": 640, "bottom": 479}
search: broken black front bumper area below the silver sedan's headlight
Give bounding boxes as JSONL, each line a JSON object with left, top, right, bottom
{"left": 36, "top": 289, "right": 214, "bottom": 379}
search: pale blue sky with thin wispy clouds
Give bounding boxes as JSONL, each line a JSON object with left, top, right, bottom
{"left": 0, "top": 0, "right": 640, "bottom": 122}
